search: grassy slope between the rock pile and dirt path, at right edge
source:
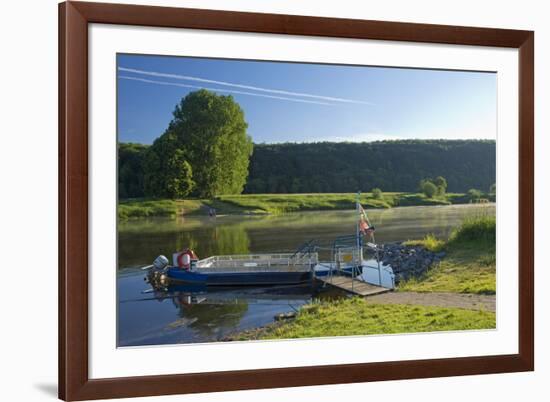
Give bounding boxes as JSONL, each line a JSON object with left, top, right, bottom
{"left": 399, "top": 215, "right": 496, "bottom": 294}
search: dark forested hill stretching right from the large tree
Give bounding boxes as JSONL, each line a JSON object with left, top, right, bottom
{"left": 244, "top": 140, "right": 496, "bottom": 193}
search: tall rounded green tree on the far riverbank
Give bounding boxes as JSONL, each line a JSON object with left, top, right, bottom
{"left": 145, "top": 90, "right": 252, "bottom": 197}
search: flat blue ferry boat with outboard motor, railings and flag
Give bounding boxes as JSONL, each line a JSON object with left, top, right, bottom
{"left": 145, "top": 194, "right": 394, "bottom": 288}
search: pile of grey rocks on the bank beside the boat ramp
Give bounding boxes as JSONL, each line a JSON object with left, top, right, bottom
{"left": 380, "top": 243, "right": 445, "bottom": 283}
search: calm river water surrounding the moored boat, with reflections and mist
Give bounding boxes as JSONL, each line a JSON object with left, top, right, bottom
{"left": 117, "top": 204, "right": 495, "bottom": 346}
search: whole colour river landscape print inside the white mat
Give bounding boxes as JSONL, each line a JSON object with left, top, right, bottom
{"left": 116, "top": 54, "right": 497, "bottom": 347}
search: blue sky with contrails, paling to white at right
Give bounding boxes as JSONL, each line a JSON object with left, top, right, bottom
{"left": 117, "top": 55, "right": 497, "bottom": 144}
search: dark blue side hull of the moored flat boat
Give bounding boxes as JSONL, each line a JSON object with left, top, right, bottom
{"left": 167, "top": 268, "right": 311, "bottom": 286}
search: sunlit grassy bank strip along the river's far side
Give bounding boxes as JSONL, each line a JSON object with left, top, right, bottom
{"left": 118, "top": 193, "right": 488, "bottom": 219}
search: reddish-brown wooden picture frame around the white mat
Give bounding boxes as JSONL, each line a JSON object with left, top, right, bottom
{"left": 59, "top": 2, "right": 534, "bottom": 400}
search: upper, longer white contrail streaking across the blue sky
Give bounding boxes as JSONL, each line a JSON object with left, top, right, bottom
{"left": 118, "top": 67, "right": 372, "bottom": 105}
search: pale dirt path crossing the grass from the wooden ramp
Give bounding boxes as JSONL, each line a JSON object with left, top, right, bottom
{"left": 366, "top": 292, "right": 496, "bottom": 312}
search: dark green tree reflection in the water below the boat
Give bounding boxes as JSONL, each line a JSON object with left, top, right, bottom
{"left": 173, "top": 295, "right": 248, "bottom": 337}
